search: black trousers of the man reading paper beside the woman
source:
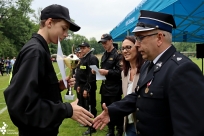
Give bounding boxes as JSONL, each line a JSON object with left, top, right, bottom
{"left": 101, "top": 95, "right": 124, "bottom": 133}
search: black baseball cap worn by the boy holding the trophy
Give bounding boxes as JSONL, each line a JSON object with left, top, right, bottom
{"left": 40, "top": 4, "right": 81, "bottom": 32}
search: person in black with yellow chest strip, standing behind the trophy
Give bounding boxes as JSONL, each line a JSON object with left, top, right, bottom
{"left": 76, "top": 42, "right": 99, "bottom": 135}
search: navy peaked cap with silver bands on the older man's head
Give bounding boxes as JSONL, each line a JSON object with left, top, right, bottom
{"left": 132, "top": 10, "right": 176, "bottom": 33}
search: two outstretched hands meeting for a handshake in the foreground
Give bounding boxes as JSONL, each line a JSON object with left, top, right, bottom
{"left": 71, "top": 99, "right": 110, "bottom": 130}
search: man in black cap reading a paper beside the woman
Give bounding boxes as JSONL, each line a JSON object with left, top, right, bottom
{"left": 98, "top": 34, "right": 124, "bottom": 136}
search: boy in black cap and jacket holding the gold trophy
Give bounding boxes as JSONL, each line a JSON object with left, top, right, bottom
{"left": 4, "top": 5, "right": 93, "bottom": 136}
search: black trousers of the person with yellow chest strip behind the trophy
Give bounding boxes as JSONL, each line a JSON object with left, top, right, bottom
{"left": 79, "top": 82, "right": 97, "bottom": 117}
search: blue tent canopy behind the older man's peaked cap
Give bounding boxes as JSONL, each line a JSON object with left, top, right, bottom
{"left": 110, "top": 0, "right": 204, "bottom": 43}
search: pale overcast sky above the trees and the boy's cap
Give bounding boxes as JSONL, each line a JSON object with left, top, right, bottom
{"left": 31, "top": 0, "right": 141, "bottom": 40}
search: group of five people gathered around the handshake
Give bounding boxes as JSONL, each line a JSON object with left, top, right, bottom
{"left": 4, "top": 4, "right": 204, "bottom": 136}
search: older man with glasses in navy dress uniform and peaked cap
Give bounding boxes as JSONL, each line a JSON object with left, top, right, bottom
{"left": 94, "top": 10, "right": 204, "bottom": 136}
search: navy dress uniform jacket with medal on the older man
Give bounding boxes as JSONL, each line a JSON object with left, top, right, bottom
{"left": 108, "top": 45, "right": 204, "bottom": 136}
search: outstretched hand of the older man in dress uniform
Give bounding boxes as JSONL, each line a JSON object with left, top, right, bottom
{"left": 93, "top": 103, "right": 110, "bottom": 130}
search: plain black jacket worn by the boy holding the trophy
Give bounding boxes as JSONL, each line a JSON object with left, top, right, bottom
{"left": 4, "top": 34, "right": 73, "bottom": 136}
